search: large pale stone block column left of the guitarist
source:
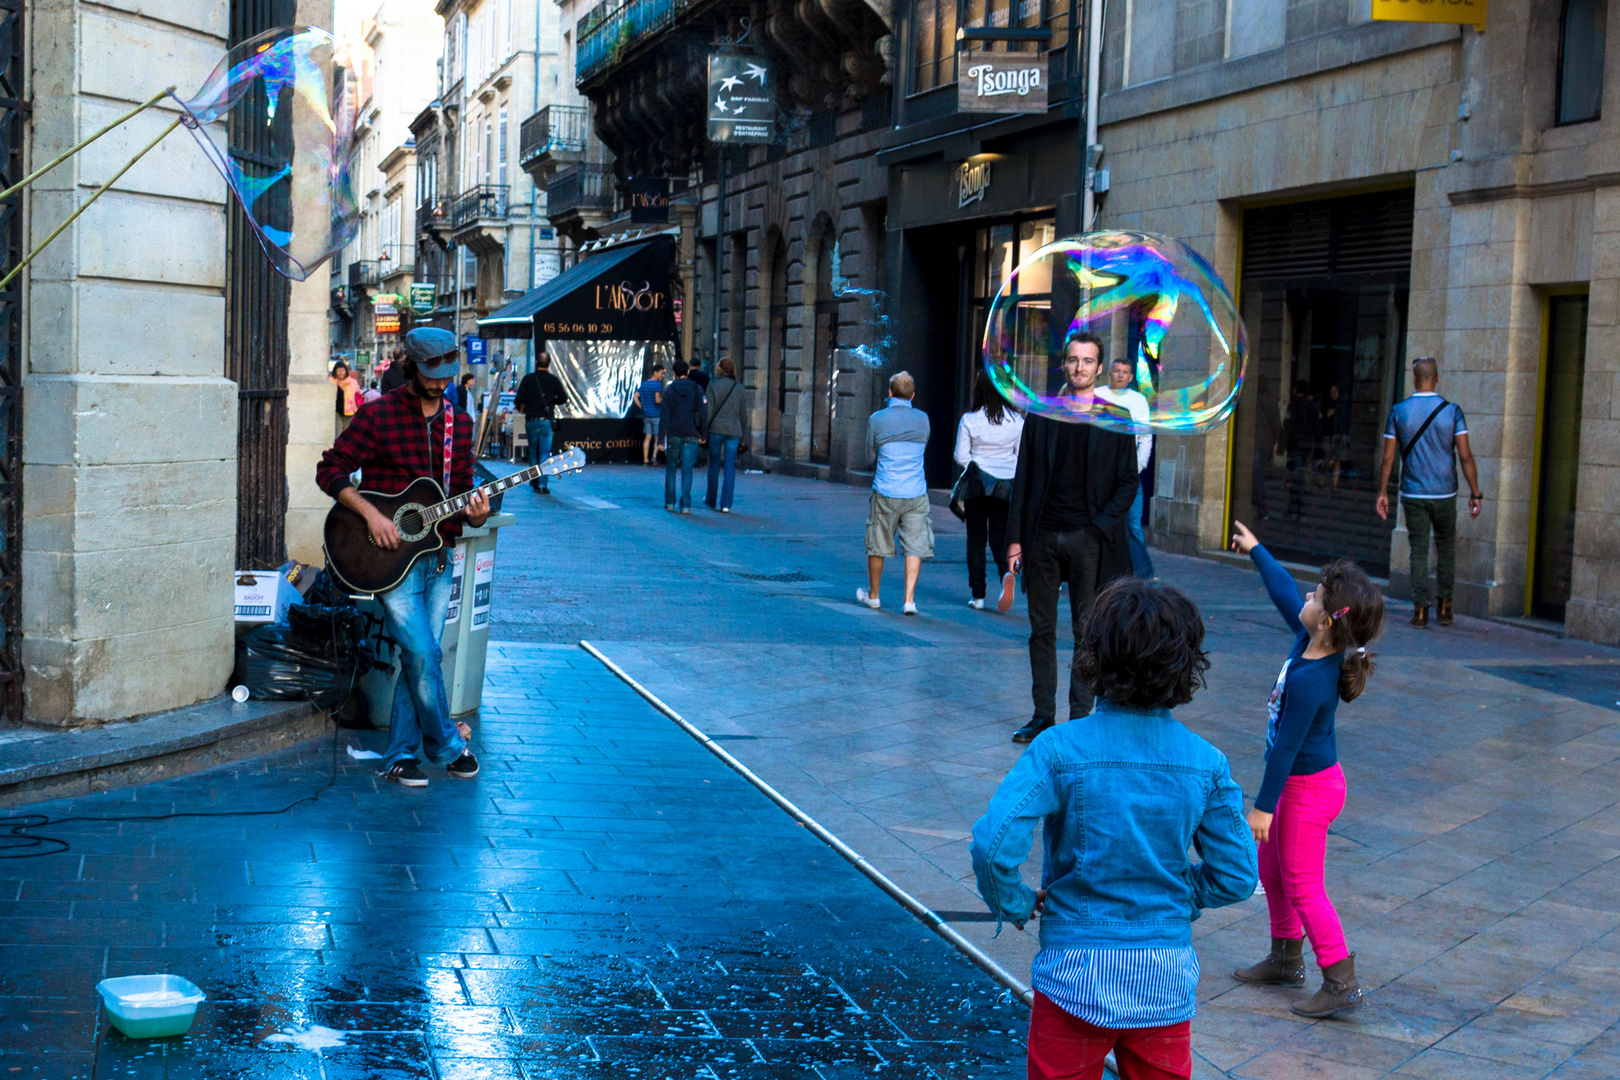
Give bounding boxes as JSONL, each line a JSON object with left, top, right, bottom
{"left": 23, "top": 0, "right": 237, "bottom": 725}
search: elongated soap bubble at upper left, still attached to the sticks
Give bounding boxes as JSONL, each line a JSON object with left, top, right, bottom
{"left": 181, "top": 26, "right": 360, "bottom": 282}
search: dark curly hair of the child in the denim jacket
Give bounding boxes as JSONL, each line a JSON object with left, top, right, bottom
{"left": 1074, "top": 578, "right": 1210, "bottom": 709}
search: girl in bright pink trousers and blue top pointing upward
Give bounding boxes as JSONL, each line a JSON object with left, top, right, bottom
{"left": 1231, "top": 521, "right": 1383, "bottom": 1018}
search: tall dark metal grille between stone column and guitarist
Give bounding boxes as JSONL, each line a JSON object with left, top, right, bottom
{"left": 225, "top": 0, "right": 298, "bottom": 570}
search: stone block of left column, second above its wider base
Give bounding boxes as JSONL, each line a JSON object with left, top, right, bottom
{"left": 76, "top": 191, "right": 225, "bottom": 290}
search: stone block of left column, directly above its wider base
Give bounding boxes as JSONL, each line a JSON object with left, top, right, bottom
{"left": 75, "top": 280, "right": 225, "bottom": 377}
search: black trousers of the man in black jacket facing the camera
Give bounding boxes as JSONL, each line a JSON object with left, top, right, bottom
{"left": 1024, "top": 529, "right": 1102, "bottom": 721}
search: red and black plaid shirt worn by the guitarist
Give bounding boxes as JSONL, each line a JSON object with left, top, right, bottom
{"left": 314, "top": 387, "right": 473, "bottom": 542}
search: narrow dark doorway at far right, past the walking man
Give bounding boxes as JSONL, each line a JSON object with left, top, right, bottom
{"left": 1526, "top": 296, "right": 1588, "bottom": 622}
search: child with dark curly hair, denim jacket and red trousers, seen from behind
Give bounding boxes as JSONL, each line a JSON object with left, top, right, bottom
{"left": 972, "top": 578, "right": 1257, "bottom": 1080}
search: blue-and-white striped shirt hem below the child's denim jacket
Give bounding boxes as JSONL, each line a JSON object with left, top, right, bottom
{"left": 1030, "top": 946, "right": 1199, "bottom": 1028}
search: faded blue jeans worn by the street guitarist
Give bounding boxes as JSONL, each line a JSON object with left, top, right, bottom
{"left": 377, "top": 549, "right": 471, "bottom": 769}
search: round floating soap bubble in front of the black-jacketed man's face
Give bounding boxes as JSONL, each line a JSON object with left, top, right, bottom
{"left": 985, "top": 232, "right": 1249, "bottom": 434}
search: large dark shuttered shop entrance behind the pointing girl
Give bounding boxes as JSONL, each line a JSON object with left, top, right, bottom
{"left": 1230, "top": 191, "right": 1413, "bottom": 576}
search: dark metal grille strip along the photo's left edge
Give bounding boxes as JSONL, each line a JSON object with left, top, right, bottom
{"left": 0, "top": 0, "right": 28, "bottom": 721}
